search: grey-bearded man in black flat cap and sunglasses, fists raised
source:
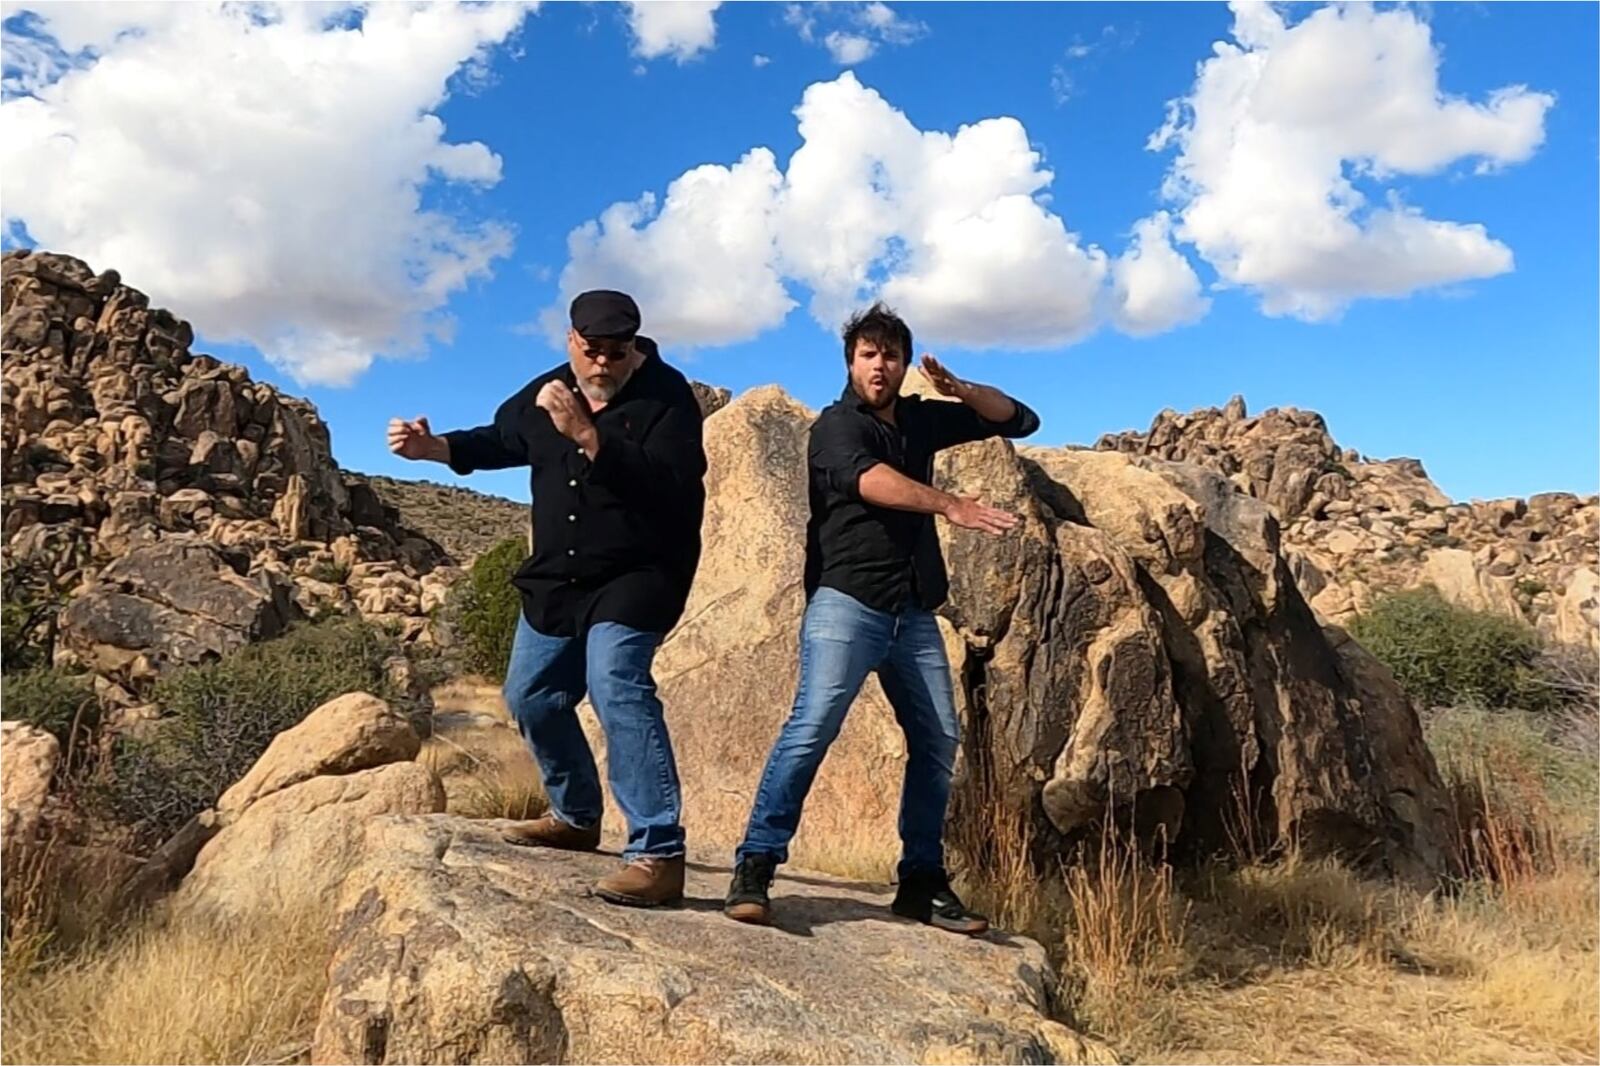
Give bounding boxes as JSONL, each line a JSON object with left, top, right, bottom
{"left": 389, "top": 291, "right": 706, "bottom": 906}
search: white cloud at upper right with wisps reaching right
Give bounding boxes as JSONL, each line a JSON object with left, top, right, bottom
{"left": 1150, "top": 0, "right": 1555, "bottom": 320}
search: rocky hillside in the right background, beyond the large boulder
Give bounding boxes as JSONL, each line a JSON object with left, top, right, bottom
{"left": 1096, "top": 397, "right": 1600, "bottom": 647}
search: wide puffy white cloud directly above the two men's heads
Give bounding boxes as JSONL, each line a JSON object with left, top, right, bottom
{"left": 546, "top": 72, "right": 1205, "bottom": 347}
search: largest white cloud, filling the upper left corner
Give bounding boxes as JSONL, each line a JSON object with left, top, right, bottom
{"left": 0, "top": 3, "right": 528, "bottom": 384}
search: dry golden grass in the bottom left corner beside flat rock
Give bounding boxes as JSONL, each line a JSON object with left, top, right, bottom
{"left": 0, "top": 896, "right": 328, "bottom": 1063}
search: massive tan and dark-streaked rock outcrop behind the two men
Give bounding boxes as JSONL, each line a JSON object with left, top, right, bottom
{"left": 597, "top": 377, "right": 1445, "bottom": 880}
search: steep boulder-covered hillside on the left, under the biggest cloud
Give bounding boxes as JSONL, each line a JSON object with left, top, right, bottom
{"left": 0, "top": 250, "right": 464, "bottom": 703}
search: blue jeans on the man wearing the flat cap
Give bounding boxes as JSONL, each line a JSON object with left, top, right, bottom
{"left": 506, "top": 618, "right": 683, "bottom": 858}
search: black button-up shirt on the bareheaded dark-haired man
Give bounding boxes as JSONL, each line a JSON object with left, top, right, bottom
{"left": 805, "top": 384, "right": 1038, "bottom": 611}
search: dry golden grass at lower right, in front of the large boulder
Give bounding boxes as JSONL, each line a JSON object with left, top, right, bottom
{"left": 952, "top": 711, "right": 1600, "bottom": 1063}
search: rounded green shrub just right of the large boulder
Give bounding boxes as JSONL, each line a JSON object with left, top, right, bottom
{"left": 1350, "top": 586, "right": 1552, "bottom": 711}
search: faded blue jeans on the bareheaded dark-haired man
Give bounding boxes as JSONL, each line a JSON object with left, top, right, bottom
{"left": 736, "top": 587, "right": 960, "bottom": 879}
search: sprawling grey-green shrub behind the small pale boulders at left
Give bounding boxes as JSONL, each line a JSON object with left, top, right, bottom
{"left": 99, "top": 618, "right": 397, "bottom": 839}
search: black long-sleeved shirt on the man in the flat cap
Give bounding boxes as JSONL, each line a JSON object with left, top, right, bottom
{"left": 445, "top": 338, "right": 706, "bottom": 637}
